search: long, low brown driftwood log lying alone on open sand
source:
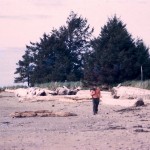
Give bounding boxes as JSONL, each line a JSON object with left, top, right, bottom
{"left": 10, "top": 110, "right": 77, "bottom": 118}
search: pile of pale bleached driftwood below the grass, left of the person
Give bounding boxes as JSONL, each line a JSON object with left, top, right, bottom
{"left": 6, "top": 86, "right": 82, "bottom": 102}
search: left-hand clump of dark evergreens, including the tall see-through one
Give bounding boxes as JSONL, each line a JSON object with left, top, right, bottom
{"left": 15, "top": 12, "right": 93, "bottom": 85}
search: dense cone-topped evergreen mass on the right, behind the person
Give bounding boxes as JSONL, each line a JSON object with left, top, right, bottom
{"left": 85, "top": 16, "right": 150, "bottom": 84}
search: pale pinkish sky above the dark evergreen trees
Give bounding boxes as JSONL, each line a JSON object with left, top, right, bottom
{"left": 0, "top": 0, "right": 150, "bottom": 87}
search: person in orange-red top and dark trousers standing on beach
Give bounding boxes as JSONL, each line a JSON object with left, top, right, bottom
{"left": 90, "top": 86, "right": 101, "bottom": 115}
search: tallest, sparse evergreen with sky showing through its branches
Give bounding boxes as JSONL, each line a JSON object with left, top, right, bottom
{"left": 66, "top": 12, "right": 94, "bottom": 80}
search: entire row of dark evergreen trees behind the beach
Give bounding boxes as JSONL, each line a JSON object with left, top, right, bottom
{"left": 14, "top": 12, "right": 150, "bottom": 86}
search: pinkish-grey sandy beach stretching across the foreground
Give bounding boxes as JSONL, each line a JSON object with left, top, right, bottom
{"left": 0, "top": 92, "right": 150, "bottom": 150}
